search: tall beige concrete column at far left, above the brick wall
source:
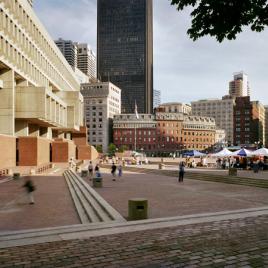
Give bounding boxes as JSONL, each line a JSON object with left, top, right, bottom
{"left": 0, "top": 70, "right": 15, "bottom": 136}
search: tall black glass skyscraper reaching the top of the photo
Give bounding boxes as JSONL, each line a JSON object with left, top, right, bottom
{"left": 97, "top": 0, "right": 153, "bottom": 113}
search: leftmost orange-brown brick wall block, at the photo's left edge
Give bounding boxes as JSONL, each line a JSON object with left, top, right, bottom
{"left": 0, "top": 135, "right": 16, "bottom": 170}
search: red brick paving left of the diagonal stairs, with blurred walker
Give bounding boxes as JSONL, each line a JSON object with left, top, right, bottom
{"left": 0, "top": 176, "right": 80, "bottom": 231}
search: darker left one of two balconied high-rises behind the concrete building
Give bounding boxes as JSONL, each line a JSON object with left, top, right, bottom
{"left": 55, "top": 38, "right": 77, "bottom": 69}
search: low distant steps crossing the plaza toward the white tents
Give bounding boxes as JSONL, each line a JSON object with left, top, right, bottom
{"left": 102, "top": 165, "right": 268, "bottom": 188}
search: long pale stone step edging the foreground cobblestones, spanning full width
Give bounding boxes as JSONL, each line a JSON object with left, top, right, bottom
{"left": 0, "top": 207, "right": 268, "bottom": 248}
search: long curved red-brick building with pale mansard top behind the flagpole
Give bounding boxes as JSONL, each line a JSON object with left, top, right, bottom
{"left": 113, "top": 112, "right": 216, "bottom": 154}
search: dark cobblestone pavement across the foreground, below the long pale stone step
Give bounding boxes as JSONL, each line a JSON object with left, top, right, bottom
{"left": 0, "top": 215, "right": 268, "bottom": 268}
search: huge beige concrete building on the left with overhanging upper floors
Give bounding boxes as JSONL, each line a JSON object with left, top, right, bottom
{"left": 0, "top": 0, "right": 94, "bottom": 169}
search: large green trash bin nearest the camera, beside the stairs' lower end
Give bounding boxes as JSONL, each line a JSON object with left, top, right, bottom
{"left": 128, "top": 198, "right": 148, "bottom": 221}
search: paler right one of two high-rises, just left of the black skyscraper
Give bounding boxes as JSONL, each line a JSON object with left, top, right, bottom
{"left": 76, "top": 43, "right": 97, "bottom": 80}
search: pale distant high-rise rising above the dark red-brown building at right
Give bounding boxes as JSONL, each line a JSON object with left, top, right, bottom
{"left": 229, "top": 72, "right": 250, "bottom": 98}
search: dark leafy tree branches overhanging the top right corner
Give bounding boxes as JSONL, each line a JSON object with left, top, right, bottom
{"left": 171, "top": 0, "right": 268, "bottom": 42}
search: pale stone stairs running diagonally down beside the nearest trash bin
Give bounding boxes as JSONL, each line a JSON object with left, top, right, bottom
{"left": 63, "top": 170, "right": 126, "bottom": 224}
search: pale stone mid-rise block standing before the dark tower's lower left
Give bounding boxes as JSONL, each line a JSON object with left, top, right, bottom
{"left": 81, "top": 82, "right": 121, "bottom": 152}
